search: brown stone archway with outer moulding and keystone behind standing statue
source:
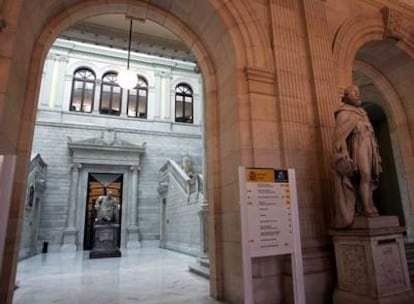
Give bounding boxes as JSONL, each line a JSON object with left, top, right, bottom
{"left": 333, "top": 7, "right": 414, "bottom": 240}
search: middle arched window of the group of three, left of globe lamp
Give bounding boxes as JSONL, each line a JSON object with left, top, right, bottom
{"left": 99, "top": 72, "right": 122, "bottom": 115}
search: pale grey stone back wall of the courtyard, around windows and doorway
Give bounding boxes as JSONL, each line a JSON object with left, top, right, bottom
{"left": 23, "top": 40, "right": 202, "bottom": 254}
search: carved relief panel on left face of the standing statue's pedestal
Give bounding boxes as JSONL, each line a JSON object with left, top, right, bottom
{"left": 337, "top": 245, "right": 369, "bottom": 294}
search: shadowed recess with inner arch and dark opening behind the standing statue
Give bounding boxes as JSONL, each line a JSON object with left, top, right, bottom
{"left": 353, "top": 40, "right": 413, "bottom": 240}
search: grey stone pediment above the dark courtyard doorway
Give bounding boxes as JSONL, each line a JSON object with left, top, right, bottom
{"left": 68, "top": 130, "right": 146, "bottom": 166}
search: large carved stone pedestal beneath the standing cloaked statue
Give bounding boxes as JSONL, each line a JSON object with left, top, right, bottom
{"left": 330, "top": 216, "right": 413, "bottom": 304}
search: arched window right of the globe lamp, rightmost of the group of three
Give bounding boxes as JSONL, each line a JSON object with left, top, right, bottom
{"left": 127, "top": 76, "right": 148, "bottom": 118}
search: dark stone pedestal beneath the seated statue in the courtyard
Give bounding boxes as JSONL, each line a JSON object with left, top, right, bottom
{"left": 89, "top": 224, "right": 121, "bottom": 259}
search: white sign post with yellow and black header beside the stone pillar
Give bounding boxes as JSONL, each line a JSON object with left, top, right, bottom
{"left": 239, "top": 167, "right": 305, "bottom": 304}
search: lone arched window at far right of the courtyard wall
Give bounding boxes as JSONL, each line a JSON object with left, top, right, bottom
{"left": 175, "top": 83, "right": 193, "bottom": 123}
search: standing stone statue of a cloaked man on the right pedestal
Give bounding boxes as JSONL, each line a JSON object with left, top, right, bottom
{"left": 334, "top": 85, "right": 382, "bottom": 228}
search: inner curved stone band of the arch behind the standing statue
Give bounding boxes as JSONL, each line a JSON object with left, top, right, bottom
{"left": 354, "top": 60, "right": 414, "bottom": 239}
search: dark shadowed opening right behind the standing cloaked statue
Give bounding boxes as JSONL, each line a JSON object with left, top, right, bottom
{"left": 363, "top": 103, "right": 405, "bottom": 225}
